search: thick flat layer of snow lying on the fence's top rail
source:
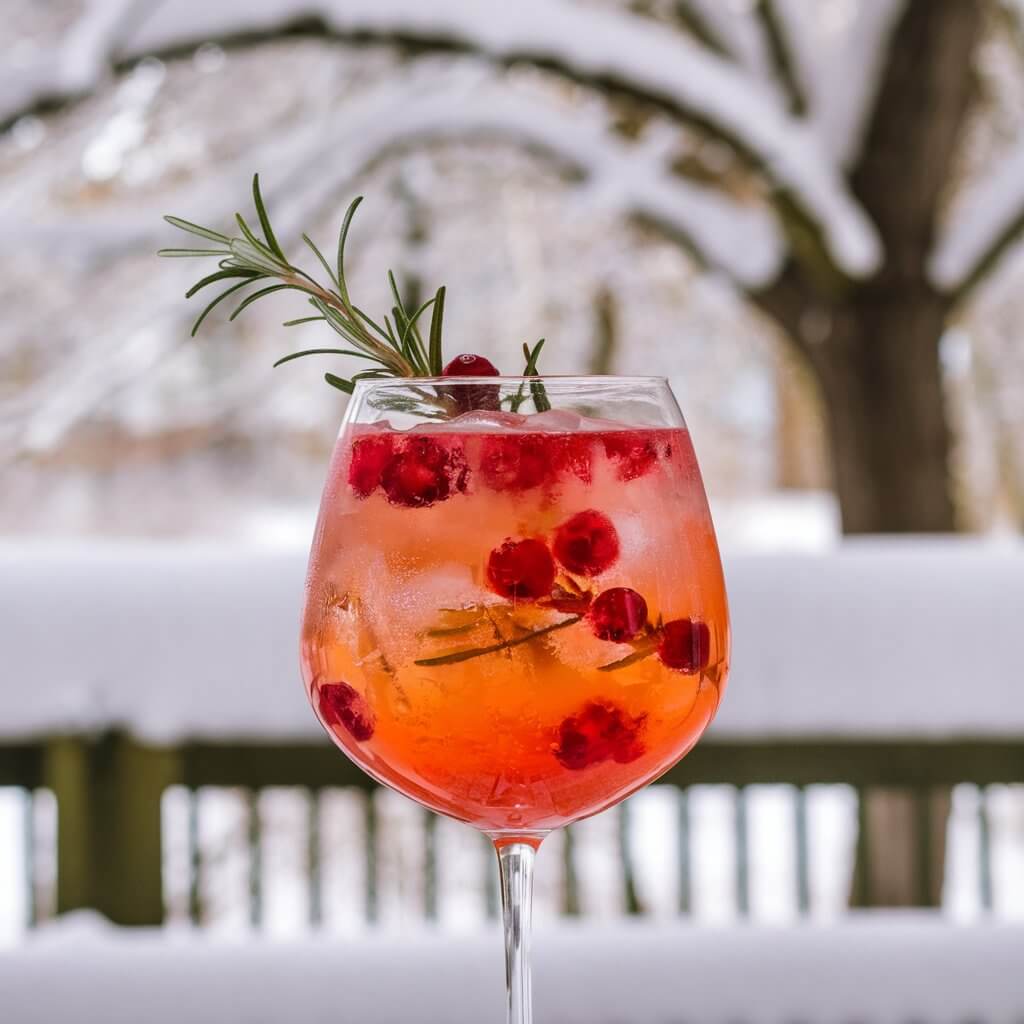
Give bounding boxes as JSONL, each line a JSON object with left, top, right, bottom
{"left": 0, "top": 540, "right": 1024, "bottom": 741}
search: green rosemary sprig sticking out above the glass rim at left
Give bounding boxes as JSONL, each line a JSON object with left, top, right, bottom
{"left": 159, "top": 174, "right": 450, "bottom": 395}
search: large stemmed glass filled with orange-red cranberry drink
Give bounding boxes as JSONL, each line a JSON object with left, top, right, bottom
{"left": 301, "top": 377, "right": 729, "bottom": 1024}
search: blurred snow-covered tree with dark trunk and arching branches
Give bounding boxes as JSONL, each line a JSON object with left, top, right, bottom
{"left": 8, "top": 0, "right": 1024, "bottom": 532}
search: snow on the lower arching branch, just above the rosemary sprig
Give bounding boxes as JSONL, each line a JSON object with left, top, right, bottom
{"left": 3, "top": 74, "right": 782, "bottom": 287}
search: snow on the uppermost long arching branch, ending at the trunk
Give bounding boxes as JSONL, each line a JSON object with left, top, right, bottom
{"left": 118, "top": 0, "right": 882, "bottom": 276}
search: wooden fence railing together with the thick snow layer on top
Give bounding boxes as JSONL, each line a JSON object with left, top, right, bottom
{"left": 6, "top": 541, "right": 1024, "bottom": 924}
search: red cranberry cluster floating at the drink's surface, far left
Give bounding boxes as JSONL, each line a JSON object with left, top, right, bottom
{"left": 348, "top": 434, "right": 469, "bottom": 509}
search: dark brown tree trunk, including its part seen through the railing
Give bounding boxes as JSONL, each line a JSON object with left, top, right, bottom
{"left": 757, "top": 0, "right": 986, "bottom": 906}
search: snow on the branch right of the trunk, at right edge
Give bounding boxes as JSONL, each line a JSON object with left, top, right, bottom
{"left": 929, "top": 138, "right": 1024, "bottom": 291}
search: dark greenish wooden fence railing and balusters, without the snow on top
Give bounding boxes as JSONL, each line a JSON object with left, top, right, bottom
{"left": 0, "top": 733, "right": 1024, "bottom": 925}
